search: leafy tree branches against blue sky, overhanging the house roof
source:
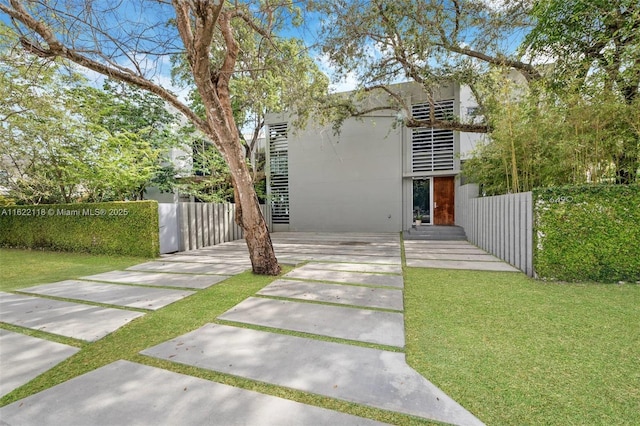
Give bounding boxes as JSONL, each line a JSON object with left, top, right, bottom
{"left": 316, "top": 0, "right": 540, "bottom": 133}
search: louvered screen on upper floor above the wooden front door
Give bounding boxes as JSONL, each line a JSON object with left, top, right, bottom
{"left": 411, "top": 99, "right": 455, "bottom": 172}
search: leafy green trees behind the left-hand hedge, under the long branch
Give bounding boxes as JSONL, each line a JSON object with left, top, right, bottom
{"left": 0, "top": 22, "right": 185, "bottom": 204}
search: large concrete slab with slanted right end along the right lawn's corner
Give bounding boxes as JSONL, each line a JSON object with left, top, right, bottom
{"left": 142, "top": 324, "right": 482, "bottom": 425}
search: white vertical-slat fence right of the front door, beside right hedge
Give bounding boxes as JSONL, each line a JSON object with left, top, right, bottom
{"left": 456, "top": 184, "right": 534, "bottom": 277}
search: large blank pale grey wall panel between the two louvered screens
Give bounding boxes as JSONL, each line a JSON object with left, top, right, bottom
{"left": 289, "top": 114, "right": 402, "bottom": 232}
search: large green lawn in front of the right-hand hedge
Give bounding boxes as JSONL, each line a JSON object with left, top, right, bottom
{"left": 405, "top": 268, "right": 640, "bottom": 425}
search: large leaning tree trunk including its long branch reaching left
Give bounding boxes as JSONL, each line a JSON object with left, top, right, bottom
{"left": 0, "top": 0, "right": 280, "bottom": 275}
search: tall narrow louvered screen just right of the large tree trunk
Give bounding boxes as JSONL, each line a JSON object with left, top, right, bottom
{"left": 269, "top": 123, "right": 289, "bottom": 225}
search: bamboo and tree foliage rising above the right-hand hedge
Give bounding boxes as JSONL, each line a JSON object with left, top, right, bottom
{"left": 465, "top": 0, "right": 640, "bottom": 193}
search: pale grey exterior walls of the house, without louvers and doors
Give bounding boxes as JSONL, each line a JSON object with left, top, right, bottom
{"left": 267, "top": 83, "right": 483, "bottom": 232}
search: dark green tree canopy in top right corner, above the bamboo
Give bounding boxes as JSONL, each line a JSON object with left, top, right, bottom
{"left": 521, "top": 0, "right": 640, "bottom": 102}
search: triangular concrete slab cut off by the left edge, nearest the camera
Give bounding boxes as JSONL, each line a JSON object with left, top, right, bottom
{"left": 0, "top": 329, "right": 80, "bottom": 396}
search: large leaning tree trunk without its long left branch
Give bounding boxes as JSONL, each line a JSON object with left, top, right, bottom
{"left": 173, "top": 0, "right": 280, "bottom": 275}
